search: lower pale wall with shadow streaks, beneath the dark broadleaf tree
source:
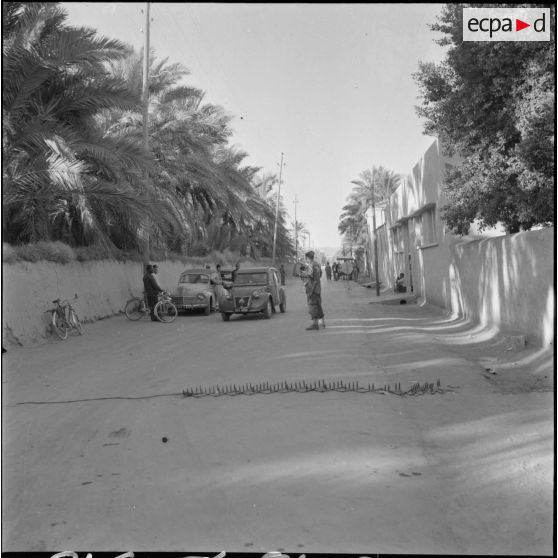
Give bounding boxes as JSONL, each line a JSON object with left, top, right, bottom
{"left": 446, "top": 227, "right": 555, "bottom": 346}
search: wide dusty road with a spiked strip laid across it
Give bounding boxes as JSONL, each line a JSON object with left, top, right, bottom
{"left": 3, "top": 279, "right": 553, "bottom": 555}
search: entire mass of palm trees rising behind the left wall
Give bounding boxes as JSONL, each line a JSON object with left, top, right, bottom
{"left": 2, "top": 2, "right": 298, "bottom": 257}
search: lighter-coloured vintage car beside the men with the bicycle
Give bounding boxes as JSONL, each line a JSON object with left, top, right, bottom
{"left": 172, "top": 268, "right": 217, "bottom": 316}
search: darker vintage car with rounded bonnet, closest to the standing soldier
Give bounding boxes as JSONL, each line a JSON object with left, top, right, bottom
{"left": 219, "top": 267, "right": 287, "bottom": 322}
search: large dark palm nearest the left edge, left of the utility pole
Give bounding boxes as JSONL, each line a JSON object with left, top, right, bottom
{"left": 2, "top": 2, "right": 173, "bottom": 252}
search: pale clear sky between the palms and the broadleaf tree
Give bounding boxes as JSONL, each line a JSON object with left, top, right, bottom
{"left": 61, "top": 2, "right": 445, "bottom": 248}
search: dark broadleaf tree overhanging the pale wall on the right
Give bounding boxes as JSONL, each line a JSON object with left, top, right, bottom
{"left": 414, "top": 4, "right": 556, "bottom": 234}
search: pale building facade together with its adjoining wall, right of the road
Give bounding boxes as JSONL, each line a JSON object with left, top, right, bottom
{"left": 379, "top": 140, "right": 555, "bottom": 345}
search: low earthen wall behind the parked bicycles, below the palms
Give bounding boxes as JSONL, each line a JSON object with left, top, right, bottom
{"left": 2, "top": 261, "right": 191, "bottom": 346}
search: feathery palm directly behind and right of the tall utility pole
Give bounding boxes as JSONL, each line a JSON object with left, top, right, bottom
{"left": 108, "top": 49, "right": 288, "bottom": 253}
